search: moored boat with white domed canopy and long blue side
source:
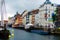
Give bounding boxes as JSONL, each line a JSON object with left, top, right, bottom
{"left": 25, "top": 24, "right": 49, "bottom": 35}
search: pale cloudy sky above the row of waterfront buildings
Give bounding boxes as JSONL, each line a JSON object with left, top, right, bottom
{"left": 0, "top": 0, "right": 60, "bottom": 17}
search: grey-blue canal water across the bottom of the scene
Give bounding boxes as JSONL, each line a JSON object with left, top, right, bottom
{"left": 0, "top": 28, "right": 60, "bottom": 40}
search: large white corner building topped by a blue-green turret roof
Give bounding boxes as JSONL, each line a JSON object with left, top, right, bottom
{"left": 35, "top": 0, "right": 56, "bottom": 28}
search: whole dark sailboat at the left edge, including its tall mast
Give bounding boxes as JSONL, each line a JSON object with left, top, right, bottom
{"left": 0, "top": 0, "right": 10, "bottom": 39}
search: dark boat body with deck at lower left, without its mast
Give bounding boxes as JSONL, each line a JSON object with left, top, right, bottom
{"left": 0, "top": 26, "right": 10, "bottom": 39}
